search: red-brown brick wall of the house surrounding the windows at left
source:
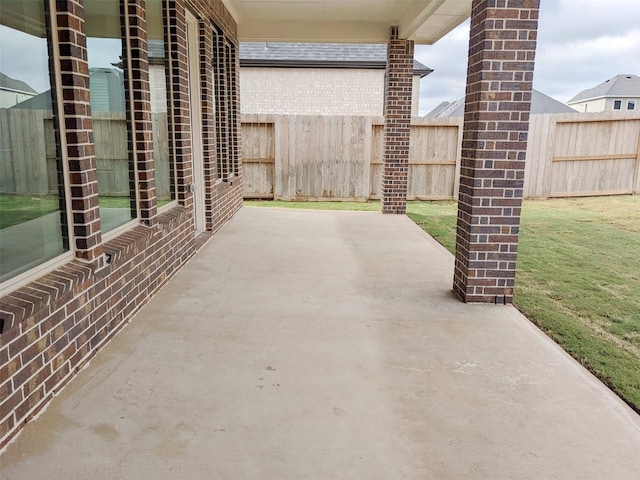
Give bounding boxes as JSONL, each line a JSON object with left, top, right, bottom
{"left": 0, "top": 0, "right": 242, "bottom": 449}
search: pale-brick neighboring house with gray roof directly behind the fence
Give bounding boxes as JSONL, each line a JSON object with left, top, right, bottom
{"left": 240, "top": 42, "right": 432, "bottom": 116}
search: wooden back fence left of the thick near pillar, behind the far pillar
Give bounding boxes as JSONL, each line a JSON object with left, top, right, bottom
{"left": 242, "top": 115, "right": 461, "bottom": 201}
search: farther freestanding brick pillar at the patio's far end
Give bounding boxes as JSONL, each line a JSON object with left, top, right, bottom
{"left": 382, "top": 27, "right": 413, "bottom": 214}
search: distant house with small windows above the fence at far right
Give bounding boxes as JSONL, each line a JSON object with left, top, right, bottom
{"left": 567, "top": 74, "right": 640, "bottom": 112}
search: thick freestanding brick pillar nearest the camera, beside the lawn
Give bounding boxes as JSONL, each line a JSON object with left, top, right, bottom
{"left": 453, "top": 0, "right": 540, "bottom": 304}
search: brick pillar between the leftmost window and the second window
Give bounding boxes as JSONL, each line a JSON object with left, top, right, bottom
{"left": 56, "top": 0, "right": 104, "bottom": 266}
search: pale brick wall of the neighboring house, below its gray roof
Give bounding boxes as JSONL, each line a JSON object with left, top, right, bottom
{"left": 240, "top": 67, "right": 420, "bottom": 116}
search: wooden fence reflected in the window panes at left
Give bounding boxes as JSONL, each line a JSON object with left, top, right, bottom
{"left": 0, "top": 108, "right": 170, "bottom": 198}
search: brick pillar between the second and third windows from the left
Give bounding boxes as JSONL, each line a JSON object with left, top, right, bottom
{"left": 120, "top": 0, "right": 157, "bottom": 226}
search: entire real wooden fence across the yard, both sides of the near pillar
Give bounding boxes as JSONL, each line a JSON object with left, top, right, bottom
{"left": 242, "top": 113, "right": 640, "bottom": 201}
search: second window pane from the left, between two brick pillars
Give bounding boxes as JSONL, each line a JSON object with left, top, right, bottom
{"left": 85, "top": 0, "right": 136, "bottom": 232}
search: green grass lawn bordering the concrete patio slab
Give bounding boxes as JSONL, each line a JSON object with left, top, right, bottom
{"left": 247, "top": 196, "right": 640, "bottom": 412}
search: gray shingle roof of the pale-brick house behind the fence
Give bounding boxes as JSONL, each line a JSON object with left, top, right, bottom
{"left": 240, "top": 42, "right": 433, "bottom": 76}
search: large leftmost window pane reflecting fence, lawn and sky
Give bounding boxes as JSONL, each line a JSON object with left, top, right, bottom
{"left": 0, "top": 0, "right": 69, "bottom": 281}
